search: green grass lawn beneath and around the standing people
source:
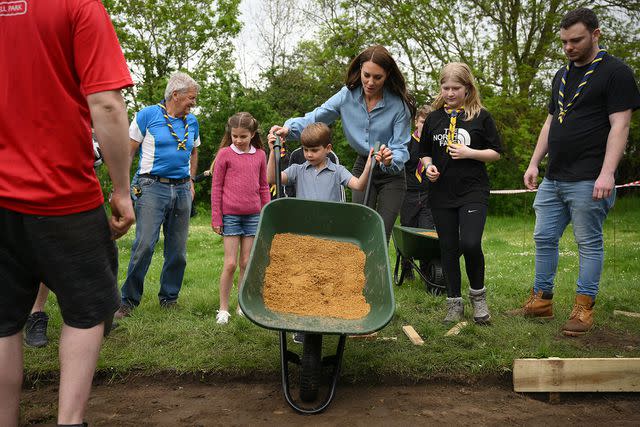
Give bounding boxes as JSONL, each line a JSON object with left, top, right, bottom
{"left": 25, "top": 196, "right": 640, "bottom": 381}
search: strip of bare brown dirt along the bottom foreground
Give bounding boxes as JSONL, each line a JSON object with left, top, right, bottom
{"left": 22, "top": 376, "right": 640, "bottom": 427}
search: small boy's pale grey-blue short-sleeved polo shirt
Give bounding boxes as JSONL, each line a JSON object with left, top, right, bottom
{"left": 283, "top": 158, "right": 353, "bottom": 202}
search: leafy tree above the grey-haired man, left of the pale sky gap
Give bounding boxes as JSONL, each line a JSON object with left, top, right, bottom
{"left": 104, "top": 0, "right": 240, "bottom": 110}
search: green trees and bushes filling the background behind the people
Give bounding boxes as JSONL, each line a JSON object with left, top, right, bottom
{"left": 100, "top": 0, "right": 640, "bottom": 214}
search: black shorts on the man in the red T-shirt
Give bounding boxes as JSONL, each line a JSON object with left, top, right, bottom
{"left": 0, "top": 207, "right": 120, "bottom": 337}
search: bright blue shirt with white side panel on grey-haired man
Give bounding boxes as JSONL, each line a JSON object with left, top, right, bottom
{"left": 129, "top": 105, "right": 200, "bottom": 179}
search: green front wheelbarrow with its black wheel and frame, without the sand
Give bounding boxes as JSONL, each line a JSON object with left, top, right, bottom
{"left": 239, "top": 198, "right": 395, "bottom": 414}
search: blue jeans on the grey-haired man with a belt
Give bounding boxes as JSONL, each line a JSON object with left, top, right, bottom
{"left": 122, "top": 178, "right": 191, "bottom": 307}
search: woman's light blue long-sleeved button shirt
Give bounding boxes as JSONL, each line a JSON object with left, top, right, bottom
{"left": 284, "top": 86, "right": 411, "bottom": 174}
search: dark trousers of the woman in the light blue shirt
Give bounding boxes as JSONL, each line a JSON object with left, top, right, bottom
{"left": 351, "top": 156, "right": 407, "bottom": 243}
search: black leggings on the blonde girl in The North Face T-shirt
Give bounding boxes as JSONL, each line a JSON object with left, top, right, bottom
{"left": 431, "top": 203, "right": 487, "bottom": 298}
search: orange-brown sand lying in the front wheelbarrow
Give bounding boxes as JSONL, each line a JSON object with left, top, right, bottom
{"left": 263, "top": 233, "right": 371, "bottom": 319}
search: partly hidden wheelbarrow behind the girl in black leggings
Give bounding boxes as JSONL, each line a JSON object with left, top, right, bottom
{"left": 392, "top": 225, "right": 447, "bottom": 294}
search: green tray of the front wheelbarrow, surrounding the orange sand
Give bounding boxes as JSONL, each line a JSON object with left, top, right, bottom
{"left": 239, "top": 198, "right": 395, "bottom": 335}
